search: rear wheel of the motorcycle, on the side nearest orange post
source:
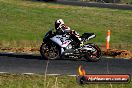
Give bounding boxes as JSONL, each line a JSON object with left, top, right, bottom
{"left": 85, "top": 44, "right": 101, "bottom": 62}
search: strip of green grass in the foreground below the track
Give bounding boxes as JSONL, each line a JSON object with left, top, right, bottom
{"left": 0, "top": 74, "right": 132, "bottom": 88}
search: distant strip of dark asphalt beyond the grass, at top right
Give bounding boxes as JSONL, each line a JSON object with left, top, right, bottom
{"left": 56, "top": 0, "right": 132, "bottom": 10}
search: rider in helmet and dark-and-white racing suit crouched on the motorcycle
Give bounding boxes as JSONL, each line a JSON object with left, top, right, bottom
{"left": 55, "top": 19, "right": 83, "bottom": 46}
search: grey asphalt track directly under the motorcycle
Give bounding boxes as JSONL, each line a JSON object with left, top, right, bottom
{"left": 0, "top": 53, "right": 132, "bottom": 75}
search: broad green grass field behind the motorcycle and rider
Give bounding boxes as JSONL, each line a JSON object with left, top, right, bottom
{"left": 0, "top": 0, "right": 132, "bottom": 49}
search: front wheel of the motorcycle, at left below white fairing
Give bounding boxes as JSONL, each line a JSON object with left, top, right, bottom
{"left": 40, "top": 43, "right": 60, "bottom": 59}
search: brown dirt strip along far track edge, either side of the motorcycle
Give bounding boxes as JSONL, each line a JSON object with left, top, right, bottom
{"left": 0, "top": 47, "right": 132, "bottom": 59}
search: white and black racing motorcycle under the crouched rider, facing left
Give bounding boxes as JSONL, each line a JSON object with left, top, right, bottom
{"left": 40, "top": 29, "right": 101, "bottom": 62}
